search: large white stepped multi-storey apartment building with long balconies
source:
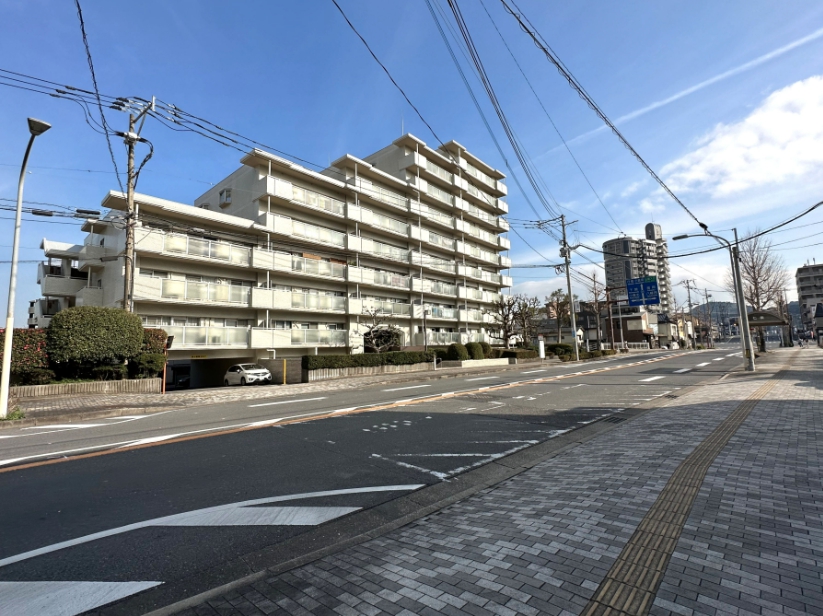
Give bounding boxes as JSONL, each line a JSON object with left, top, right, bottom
{"left": 30, "top": 134, "right": 512, "bottom": 386}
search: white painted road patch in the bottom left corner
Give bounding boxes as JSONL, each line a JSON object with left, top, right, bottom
{"left": 0, "top": 582, "right": 162, "bottom": 616}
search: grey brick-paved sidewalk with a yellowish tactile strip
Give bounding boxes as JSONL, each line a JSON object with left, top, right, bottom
{"left": 171, "top": 349, "right": 823, "bottom": 616}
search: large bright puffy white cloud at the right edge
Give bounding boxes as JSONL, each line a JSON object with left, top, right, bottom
{"left": 660, "top": 76, "right": 823, "bottom": 197}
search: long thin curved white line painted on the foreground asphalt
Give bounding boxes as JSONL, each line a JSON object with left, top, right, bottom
{"left": 0, "top": 484, "right": 425, "bottom": 567}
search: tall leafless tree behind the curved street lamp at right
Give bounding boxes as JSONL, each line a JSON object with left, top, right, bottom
{"left": 725, "top": 229, "right": 789, "bottom": 353}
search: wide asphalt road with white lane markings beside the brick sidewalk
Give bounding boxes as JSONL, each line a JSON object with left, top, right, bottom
{"left": 0, "top": 346, "right": 741, "bottom": 614}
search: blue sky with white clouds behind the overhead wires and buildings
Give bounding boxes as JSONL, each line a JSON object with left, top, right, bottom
{"left": 0, "top": 0, "right": 823, "bottom": 325}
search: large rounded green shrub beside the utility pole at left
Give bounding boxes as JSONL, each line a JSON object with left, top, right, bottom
{"left": 46, "top": 306, "right": 143, "bottom": 367}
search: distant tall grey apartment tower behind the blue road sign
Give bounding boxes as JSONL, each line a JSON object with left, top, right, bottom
{"left": 603, "top": 223, "right": 674, "bottom": 314}
